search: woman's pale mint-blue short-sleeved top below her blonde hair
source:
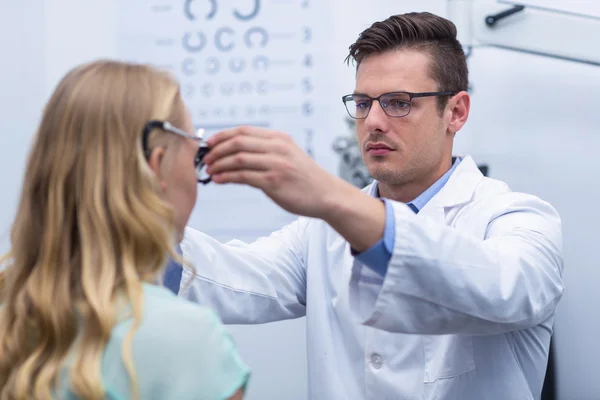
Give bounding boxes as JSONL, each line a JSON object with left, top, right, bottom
{"left": 59, "top": 284, "right": 250, "bottom": 400}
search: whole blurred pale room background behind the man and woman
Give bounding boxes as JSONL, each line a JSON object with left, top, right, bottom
{"left": 0, "top": 0, "right": 600, "bottom": 400}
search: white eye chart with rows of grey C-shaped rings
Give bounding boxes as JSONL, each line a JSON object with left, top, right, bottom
{"left": 117, "top": 0, "right": 342, "bottom": 240}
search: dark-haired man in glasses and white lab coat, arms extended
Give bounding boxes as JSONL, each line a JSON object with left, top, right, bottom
{"left": 172, "top": 13, "right": 563, "bottom": 400}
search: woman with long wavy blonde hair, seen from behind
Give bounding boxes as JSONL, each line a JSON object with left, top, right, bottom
{"left": 0, "top": 61, "right": 249, "bottom": 400}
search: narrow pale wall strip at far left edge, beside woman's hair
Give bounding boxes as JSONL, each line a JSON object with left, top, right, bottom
{"left": 0, "top": 0, "right": 44, "bottom": 252}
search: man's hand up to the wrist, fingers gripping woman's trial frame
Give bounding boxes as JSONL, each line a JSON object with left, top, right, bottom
{"left": 204, "top": 126, "right": 339, "bottom": 218}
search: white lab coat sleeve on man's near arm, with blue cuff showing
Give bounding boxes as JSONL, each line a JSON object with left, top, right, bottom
{"left": 350, "top": 193, "right": 563, "bottom": 335}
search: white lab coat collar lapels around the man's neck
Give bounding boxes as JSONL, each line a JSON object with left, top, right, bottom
{"left": 363, "top": 155, "right": 483, "bottom": 208}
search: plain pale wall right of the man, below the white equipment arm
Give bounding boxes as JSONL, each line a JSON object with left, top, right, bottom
{"left": 467, "top": 49, "right": 600, "bottom": 400}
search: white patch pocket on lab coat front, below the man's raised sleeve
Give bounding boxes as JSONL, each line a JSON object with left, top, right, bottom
{"left": 423, "top": 335, "right": 475, "bottom": 383}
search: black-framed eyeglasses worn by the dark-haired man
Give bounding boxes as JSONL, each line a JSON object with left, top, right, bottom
{"left": 342, "top": 92, "right": 457, "bottom": 119}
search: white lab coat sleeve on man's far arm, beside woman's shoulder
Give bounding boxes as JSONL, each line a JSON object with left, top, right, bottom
{"left": 179, "top": 219, "right": 308, "bottom": 324}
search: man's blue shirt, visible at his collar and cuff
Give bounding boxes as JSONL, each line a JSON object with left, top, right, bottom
{"left": 356, "top": 157, "right": 460, "bottom": 276}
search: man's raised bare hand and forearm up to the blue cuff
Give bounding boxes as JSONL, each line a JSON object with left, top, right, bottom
{"left": 204, "top": 126, "right": 385, "bottom": 252}
